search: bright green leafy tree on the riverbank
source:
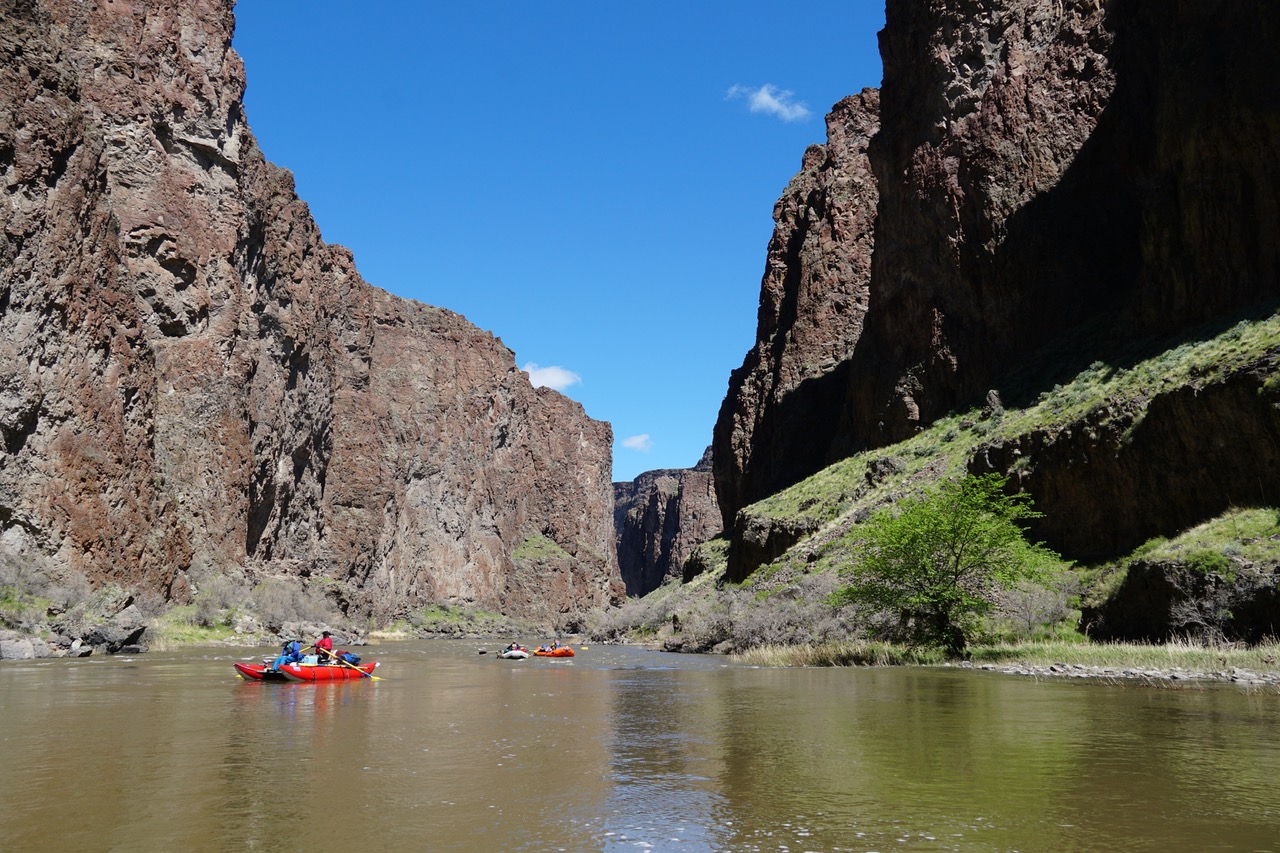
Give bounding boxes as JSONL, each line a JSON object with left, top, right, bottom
{"left": 832, "top": 474, "right": 1060, "bottom": 657}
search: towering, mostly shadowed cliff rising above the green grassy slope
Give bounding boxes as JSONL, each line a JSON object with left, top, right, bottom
{"left": 714, "top": 0, "right": 1280, "bottom": 539}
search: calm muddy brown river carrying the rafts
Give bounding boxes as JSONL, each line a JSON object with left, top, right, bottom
{"left": 0, "top": 640, "right": 1280, "bottom": 853}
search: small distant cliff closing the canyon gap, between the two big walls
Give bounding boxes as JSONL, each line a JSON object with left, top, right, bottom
{"left": 613, "top": 448, "right": 721, "bottom": 596}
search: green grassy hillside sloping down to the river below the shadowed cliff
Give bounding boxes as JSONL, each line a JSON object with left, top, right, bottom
{"left": 596, "top": 308, "right": 1280, "bottom": 651}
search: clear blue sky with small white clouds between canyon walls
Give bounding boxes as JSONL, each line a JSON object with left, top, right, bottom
{"left": 236, "top": 0, "right": 884, "bottom": 480}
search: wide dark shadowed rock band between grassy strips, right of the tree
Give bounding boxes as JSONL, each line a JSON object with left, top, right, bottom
{"left": 969, "top": 356, "right": 1280, "bottom": 561}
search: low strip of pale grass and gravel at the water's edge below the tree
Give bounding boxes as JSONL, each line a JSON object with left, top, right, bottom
{"left": 733, "top": 642, "right": 1280, "bottom": 686}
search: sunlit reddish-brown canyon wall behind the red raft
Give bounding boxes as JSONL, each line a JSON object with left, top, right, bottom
{"left": 0, "top": 0, "right": 622, "bottom": 621}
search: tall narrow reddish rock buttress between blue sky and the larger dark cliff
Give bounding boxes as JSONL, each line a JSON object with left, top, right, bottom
{"left": 713, "top": 90, "right": 879, "bottom": 529}
